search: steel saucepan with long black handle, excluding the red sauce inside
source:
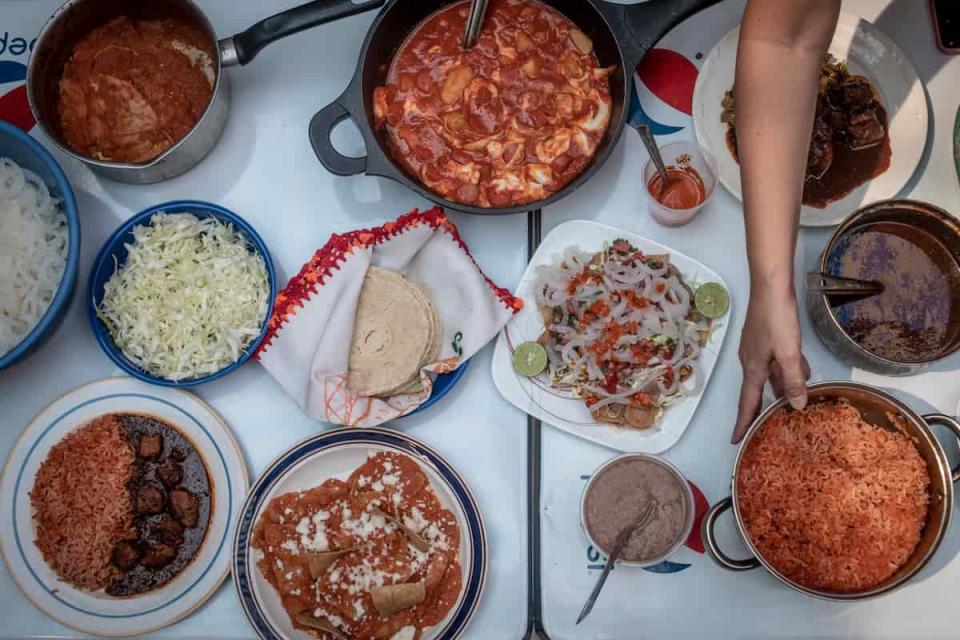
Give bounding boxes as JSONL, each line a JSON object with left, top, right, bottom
{"left": 27, "top": 0, "right": 385, "bottom": 184}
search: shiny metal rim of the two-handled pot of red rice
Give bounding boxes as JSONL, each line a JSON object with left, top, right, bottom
{"left": 730, "top": 380, "right": 953, "bottom": 602}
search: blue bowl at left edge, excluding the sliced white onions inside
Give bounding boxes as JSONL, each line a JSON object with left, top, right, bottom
{"left": 0, "top": 120, "right": 80, "bottom": 369}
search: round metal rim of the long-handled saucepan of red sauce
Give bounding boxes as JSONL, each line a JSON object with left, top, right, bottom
{"left": 27, "top": 0, "right": 223, "bottom": 171}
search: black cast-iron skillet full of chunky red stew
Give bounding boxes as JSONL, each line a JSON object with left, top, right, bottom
{"left": 310, "top": 0, "right": 717, "bottom": 214}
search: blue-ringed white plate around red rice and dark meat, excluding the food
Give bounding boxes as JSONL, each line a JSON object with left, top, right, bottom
{"left": 0, "top": 377, "right": 248, "bottom": 636}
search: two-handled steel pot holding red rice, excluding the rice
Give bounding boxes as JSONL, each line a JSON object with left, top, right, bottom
{"left": 701, "top": 382, "right": 960, "bottom": 601}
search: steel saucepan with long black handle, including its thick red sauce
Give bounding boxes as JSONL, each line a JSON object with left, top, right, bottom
{"left": 27, "top": 0, "right": 384, "bottom": 184}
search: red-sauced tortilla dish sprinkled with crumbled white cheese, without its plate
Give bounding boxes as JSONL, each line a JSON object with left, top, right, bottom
{"left": 252, "top": 453, "right": 462, "bottom": 640}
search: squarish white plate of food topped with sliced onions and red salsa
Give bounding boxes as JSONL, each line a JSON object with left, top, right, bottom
{"left": 493, "top": 220, "right": 729, "bottom": 454}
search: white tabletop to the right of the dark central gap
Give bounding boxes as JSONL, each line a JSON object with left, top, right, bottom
{"left": 541, "top": 0, "right": 960, "bottom": 640}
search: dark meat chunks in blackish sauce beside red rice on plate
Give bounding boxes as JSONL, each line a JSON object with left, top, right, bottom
{"left": 106, "top": 414, "right": 212, "bottom": 596}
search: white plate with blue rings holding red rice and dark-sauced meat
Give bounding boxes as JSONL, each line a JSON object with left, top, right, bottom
{"left": 0, "top": 378, "right": 247, "bottom": 636}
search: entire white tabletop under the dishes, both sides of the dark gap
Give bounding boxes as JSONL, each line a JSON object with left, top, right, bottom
{"left": 0, "top": 0, "right": 960, "bottom": 640}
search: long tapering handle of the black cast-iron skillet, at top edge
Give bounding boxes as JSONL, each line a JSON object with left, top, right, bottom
{"left": 596, "top": 0, "right": 720, "bottom": 73}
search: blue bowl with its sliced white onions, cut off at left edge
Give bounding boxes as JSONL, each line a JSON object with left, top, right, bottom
{"left": 0, "top": 120, "right": 80, "bottom": 369}
